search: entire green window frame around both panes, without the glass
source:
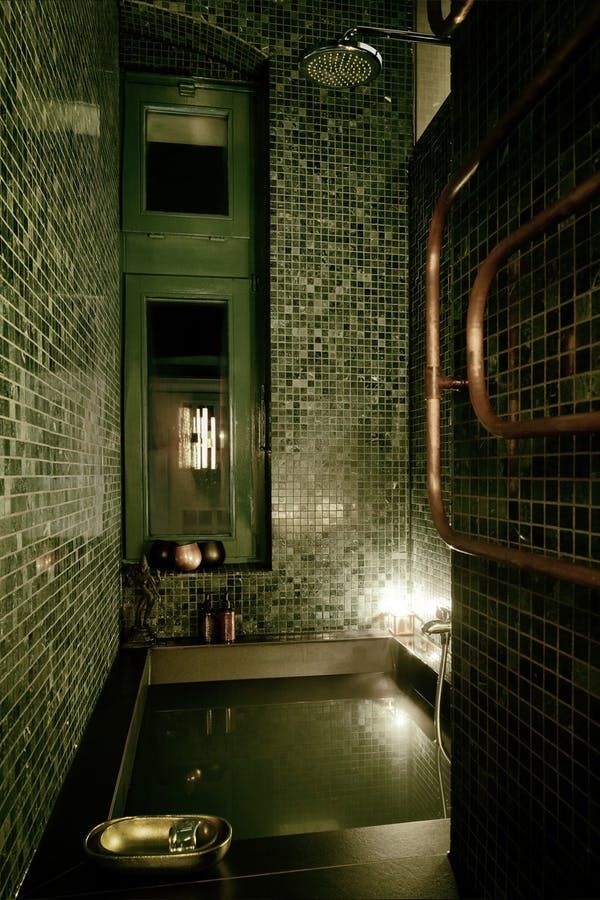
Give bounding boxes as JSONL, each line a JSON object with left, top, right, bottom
{"left": 122, "top": 79, "right": 270, "bottom": 566}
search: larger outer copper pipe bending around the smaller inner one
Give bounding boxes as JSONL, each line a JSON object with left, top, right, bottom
{"left": 425, "top": 4, "right": 600, "bottom": 587}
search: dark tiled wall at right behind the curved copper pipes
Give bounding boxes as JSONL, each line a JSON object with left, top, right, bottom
{"left": 414, "top": 0, "right": 600, "bottom": 898}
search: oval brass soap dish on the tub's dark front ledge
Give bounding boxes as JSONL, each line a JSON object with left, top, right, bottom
{"left": 84, "top": 815, "right": 232, "bottom": 872}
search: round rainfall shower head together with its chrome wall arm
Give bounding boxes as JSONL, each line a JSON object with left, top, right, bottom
{"left": 300, "top": 25, "right": 449, "bottom": 88}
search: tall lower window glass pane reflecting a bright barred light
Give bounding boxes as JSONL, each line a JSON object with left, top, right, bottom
{"left": 147, "top": 300, "right": 231, "bottom": 536}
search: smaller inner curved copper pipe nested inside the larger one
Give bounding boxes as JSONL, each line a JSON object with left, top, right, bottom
{"left": 467, "top": 173, "right": 600, "bottom": 438}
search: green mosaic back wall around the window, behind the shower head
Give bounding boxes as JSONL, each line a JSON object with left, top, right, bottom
{"left": 121, "top": 0, "right": 412, "bottom": 636}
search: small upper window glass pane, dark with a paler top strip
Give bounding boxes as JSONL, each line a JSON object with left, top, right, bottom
{"left": 145, "top": 110, "right": 229, "bottom": 216}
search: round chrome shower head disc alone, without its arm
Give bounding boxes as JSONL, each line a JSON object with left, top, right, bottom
{"left": 300, "top": 37, "right": 383, "bottom": 88}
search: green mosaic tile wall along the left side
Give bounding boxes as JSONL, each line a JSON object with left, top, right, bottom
{"left": 0, "top": 0, "right": 120, "bottom": 897}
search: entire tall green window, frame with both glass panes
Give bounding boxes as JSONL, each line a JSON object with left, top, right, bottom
{"left": 123, "top": 75, "right": 267, "bottom": 563}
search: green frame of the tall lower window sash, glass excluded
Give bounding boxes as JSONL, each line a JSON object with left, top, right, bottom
{"left": 124, "top": 275, "right": 264, "bottom": 563}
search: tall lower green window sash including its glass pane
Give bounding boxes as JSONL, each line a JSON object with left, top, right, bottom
{"left": 124, "top": 275, "right": 264, "bottom": 562}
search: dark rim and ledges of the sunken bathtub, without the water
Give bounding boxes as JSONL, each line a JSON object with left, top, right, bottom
{"left": 19, "top": 635, "right": 454, "bottom": 898}
